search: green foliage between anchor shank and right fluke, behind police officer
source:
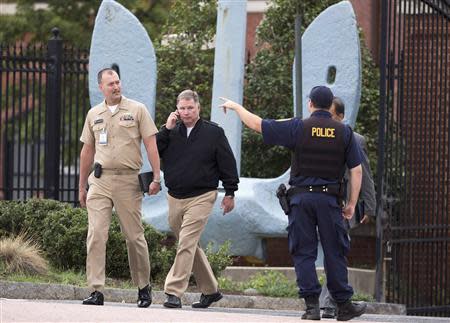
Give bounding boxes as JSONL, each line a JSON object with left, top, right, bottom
{"left": 242, "top": 0, "right": 379, "bottom": 177}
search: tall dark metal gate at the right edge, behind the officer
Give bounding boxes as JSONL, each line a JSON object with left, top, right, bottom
{"left": 377, "top": 0, "right": 450, "bottom": 316}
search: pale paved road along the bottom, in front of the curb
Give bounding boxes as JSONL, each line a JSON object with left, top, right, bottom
{"left": 0, "top": 298, "right": 449, "bottom": 323}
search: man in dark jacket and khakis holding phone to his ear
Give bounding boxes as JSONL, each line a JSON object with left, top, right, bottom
{"left": 157, "top": 90, "right": 239, "bottom": 308}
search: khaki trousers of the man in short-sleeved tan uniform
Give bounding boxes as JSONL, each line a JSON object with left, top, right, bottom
{"left": 86, "top": 172, "right": 150, "bottom": 291}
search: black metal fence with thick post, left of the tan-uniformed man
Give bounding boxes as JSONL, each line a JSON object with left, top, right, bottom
{"left": 0, "top": 29, "right": 89, "bottom": 203}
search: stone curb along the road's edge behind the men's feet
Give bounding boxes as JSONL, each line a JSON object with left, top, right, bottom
{"left": 0, "top": 281, "right": 406, "bottom": 315}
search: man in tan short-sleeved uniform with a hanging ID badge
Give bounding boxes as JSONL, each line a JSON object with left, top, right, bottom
{"left": 79, "top": 69, "right": 160, "bottom": 307}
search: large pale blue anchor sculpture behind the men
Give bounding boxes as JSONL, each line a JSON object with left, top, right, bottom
{"left": 89, "top": 0, "right": 361, "bottom": 262}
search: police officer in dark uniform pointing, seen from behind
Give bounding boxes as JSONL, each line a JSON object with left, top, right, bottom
{"left": 221, "top": 86, "right": 366, "bottom": 321}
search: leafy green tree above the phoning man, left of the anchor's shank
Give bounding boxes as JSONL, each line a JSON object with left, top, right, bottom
{"left": 155, "top": 0, "right": 217, "bottom": 125}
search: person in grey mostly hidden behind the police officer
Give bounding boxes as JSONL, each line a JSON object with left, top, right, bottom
{"left": 320, "top": 97, "right": 376, "bottom": 318}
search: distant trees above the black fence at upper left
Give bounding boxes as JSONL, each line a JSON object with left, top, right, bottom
{"left": 0, "top": 0, "right": 172, "bottom": 48}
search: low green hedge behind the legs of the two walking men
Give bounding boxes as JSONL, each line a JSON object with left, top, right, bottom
{"left": 0, "top": 199, "right": 230, "bottom": 281}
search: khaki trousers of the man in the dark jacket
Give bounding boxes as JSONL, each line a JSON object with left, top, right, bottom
{"left": 164, "top": 191, "right": 218, "bottom": 297}
